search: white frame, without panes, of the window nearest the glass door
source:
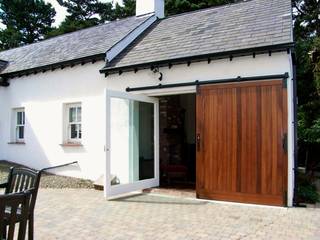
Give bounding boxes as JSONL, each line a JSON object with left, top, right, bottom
{"left": 64, "top": 103, "right": 82, "bottom": 143}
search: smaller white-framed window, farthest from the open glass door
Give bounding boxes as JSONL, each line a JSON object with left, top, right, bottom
{"left": 13, "top": 108, "right": 26, "bottom": 142}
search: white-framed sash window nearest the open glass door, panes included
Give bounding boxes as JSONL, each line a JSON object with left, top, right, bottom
{"left": 64, "top": 103, "right": 82, "bottom": 143}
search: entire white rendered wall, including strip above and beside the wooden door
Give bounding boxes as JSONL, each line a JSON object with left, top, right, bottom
{"left": 0, "top": 53, "right": 293, "bottom": 205}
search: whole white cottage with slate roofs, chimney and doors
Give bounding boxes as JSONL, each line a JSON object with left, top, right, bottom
{"left": 0, "top": 0, "right": 295, "bottom": 206}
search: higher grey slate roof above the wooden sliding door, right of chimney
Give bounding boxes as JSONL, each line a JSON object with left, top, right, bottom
{"left": 102, "top": 0, "right": 293, "bottom": 72}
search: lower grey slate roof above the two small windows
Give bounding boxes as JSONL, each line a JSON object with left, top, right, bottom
{"left": 0, "top": 16, "right": 148, "bottom": 74}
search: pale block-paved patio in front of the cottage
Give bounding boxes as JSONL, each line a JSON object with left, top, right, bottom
{"left": 35, "top": 189, "right": 320, "bottom": 240}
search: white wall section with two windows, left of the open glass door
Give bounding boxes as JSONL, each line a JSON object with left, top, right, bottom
{"left": 0, "top": 61, "right": 106, "bottom": 179}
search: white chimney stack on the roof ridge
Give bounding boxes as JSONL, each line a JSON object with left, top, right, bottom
{"left": 136, "top": 0, "right": 164, "bottom": 18}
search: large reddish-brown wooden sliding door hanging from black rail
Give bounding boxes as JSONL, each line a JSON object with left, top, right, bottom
{"left": 197, "top": 80, "right": 287, "bottom": 206}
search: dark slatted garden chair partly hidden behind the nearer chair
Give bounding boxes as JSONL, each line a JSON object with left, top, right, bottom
{"left": 0, "top": 167, "right": 42, "bottom": 240}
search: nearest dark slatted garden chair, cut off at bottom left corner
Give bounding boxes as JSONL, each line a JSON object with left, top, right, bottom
{"left": 0, "top": 191, "right": 31, "bottom": 240}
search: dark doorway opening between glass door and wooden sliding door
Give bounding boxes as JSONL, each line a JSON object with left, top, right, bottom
{"left": 159, "top": 94, "right": 196, "bottom": 190}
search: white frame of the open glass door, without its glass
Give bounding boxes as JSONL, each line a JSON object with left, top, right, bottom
{"left": 104, "top": 89, "right": 160, "bottom": 198}
